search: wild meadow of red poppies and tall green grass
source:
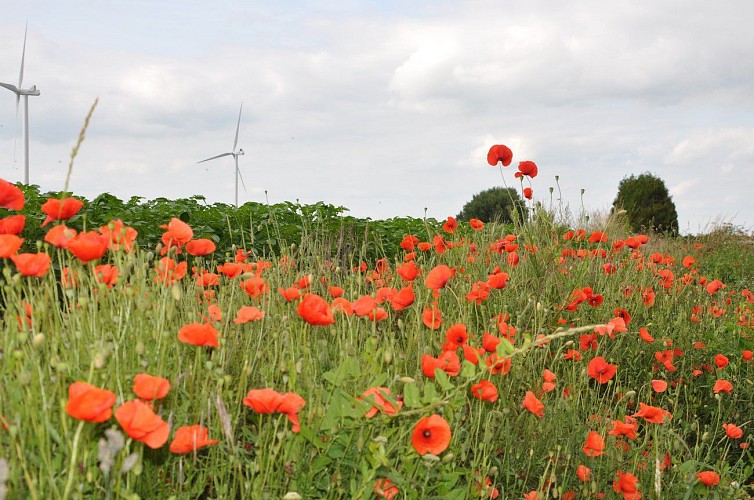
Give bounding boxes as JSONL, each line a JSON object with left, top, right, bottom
{"left": 0, "top": 162, "right": 754, "bottom": 499}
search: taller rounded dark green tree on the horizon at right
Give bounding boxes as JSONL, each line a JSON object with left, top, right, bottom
{"left": 613, "top": 172, "right": 678, "bottom": 234}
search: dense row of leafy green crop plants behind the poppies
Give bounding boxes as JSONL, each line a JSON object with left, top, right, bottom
{"left": 11, "top": 185, "right": 439, "bottom": 264}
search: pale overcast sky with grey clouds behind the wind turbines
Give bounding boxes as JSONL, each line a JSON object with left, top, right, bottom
{"left": 0, "top": 0, "right": 754, "bottom": 233}
